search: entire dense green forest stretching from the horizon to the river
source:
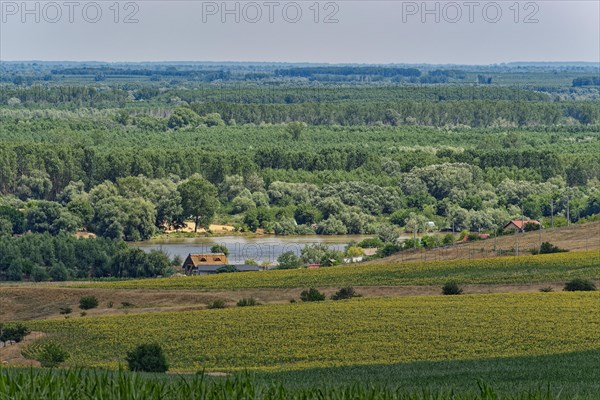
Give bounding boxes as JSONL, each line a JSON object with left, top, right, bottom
{"left": 0, "top": 63, "right": 600, "bottom": 280}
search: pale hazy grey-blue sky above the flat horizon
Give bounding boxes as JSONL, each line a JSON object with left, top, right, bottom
{"left": 0, "top": 0, "right": 600, "bottom": 64}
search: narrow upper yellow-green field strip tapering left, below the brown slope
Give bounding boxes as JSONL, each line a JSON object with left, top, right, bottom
{"left": 73, "top": 251, "right": 600, "bottom": 289}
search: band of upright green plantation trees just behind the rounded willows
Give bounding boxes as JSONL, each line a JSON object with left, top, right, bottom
{"left": 0, "top": 144, "right": 600, "bottom": 199}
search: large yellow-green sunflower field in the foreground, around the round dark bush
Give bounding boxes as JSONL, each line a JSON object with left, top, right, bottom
{"left": 22, "top": 292, "right": 600, "bottom": 371}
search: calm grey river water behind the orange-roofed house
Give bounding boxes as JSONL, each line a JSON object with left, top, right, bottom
{"left": 132, "top": 235, "right": 372, "bottom": 264}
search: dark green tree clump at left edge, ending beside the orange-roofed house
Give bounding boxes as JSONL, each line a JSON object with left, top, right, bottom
{"left": 0, "top": 234, "right": 173, "bottom": 282}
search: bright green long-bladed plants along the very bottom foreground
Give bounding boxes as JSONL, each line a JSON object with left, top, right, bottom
{"left": 0, "top": 368, "right": 592, "bottom": 400}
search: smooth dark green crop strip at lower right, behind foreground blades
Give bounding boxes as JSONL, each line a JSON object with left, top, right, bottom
{"left": 255, "top": 349, "right": 600, "bottom": 398}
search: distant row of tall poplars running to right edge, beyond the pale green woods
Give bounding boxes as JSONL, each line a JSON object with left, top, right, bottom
{"left": 191, "top": 101, "right": 600, "bottom": 127}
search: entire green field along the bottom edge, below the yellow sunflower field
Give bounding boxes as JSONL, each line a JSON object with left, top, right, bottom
{"left": 0, "top": 360, "right": 600, "bottom": 400}
